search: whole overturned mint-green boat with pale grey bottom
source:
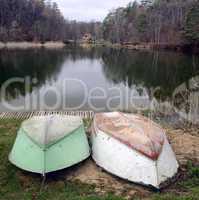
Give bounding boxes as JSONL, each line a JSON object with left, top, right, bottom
{"left": 9, "top": 115, "right": 90, "bottom": 174}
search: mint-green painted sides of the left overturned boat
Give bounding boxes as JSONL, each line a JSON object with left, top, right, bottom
{"left": 9, "top": 125, "right": 90, "bottom": 174}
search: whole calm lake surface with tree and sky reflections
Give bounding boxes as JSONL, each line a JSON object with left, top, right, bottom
{"left": 0, "top": 47, "right": 199, "bottom": 123}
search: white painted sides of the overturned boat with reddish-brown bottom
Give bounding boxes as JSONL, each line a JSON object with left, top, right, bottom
{"left": 91, "top": 113, "right": 179, "bottom": 188}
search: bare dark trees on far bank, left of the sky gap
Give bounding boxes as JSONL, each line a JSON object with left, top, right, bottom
{"left": 0, "top": 0, "right": 100, "bottom": 42}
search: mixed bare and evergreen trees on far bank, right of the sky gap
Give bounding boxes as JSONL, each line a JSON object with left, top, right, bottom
{"left": 103, "top": 0, "right": 199, "bottom": 44}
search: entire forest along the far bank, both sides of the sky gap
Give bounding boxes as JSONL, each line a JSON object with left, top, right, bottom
{"left": 0, "top": 0, "right": 199, "bottom": 48}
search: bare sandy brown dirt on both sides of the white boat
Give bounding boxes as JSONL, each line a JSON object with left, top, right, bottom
{"left": 56, "top": 129, "right": 199, "bottom": 199}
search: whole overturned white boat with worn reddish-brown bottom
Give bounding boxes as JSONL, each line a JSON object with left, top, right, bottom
{"left": 91, "top": 112, "right": 179, "bottom": 188}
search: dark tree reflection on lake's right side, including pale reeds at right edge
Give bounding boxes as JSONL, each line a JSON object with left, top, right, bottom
{"left": 102, "top": 49, "right": 199, "bottom": 123}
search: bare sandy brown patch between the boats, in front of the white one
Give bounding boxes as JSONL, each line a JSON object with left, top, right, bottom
{"left": 63, "top": 159, "right": 152, "bottom": 199}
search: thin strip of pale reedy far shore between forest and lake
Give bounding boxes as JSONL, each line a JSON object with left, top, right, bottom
{"left": 0, "top": 41, "right": 199, "bottom": 54}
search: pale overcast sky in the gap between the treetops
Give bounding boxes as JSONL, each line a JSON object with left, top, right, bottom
{"left": 53, "top": 0, "right": 134, "bottom": 21}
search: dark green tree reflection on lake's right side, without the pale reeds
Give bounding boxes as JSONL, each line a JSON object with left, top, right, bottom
{"left": 102, "top": 49, "right": 199, "bottom": 98}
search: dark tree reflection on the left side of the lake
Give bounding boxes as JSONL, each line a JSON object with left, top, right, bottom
{"left": 0, "top": 50, "right": 64, "bottom": 99}
